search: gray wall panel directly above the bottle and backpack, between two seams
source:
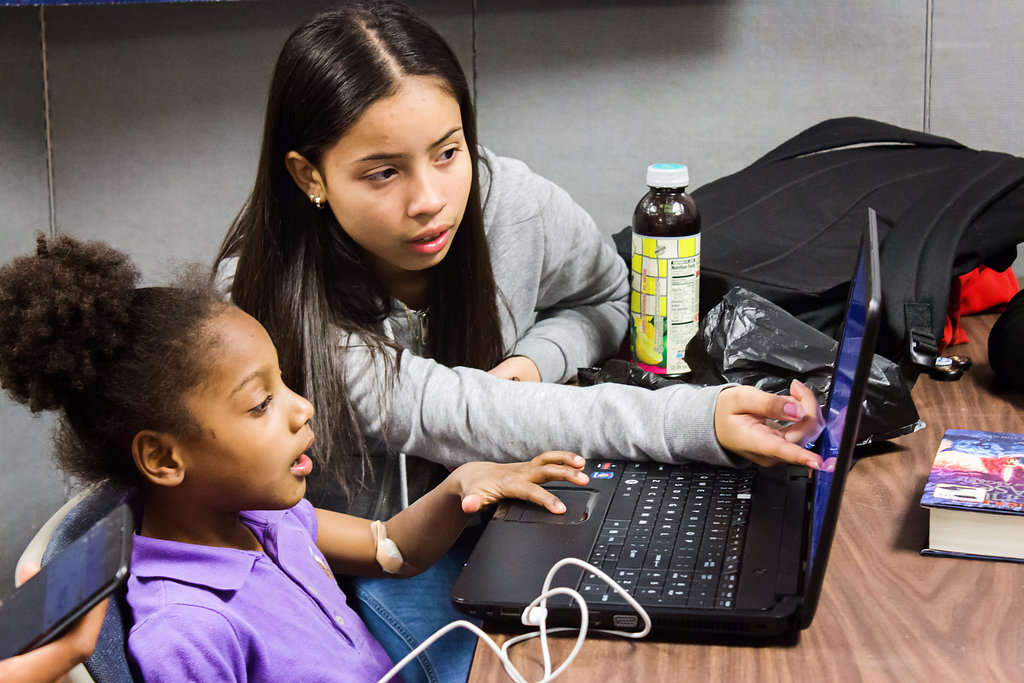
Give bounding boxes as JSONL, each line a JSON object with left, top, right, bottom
{"left": 478, "top": 0, "right": 926, "bottom": 233}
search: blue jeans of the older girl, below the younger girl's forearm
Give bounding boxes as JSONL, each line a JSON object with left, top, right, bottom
{"left": 345, "top": 528, "right": 480, "bottom": 683}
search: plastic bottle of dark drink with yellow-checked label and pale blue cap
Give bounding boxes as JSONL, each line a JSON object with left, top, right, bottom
{"left": 630, "top": 164, "right": 700, "bottom": 377}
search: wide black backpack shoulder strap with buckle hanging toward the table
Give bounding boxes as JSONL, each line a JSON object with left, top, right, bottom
{"left": 881, "top": 152, "right": 1024, "bottom": 374}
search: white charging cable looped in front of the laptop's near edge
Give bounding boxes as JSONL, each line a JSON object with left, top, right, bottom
{"left": 377, "top": 557, "right": 651, "bottom": 683}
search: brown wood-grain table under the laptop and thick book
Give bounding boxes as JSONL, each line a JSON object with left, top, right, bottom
{"left": 470, "top": 314, "right": 1024, "bottom": 683}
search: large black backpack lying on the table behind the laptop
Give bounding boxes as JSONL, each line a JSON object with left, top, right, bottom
{"left": 692, "top": 118, "right": 1024, "bottom": 381}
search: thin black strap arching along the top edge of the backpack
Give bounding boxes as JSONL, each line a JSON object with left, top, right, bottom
{"left": 754, "top": 117, "right": 964, "bottom": 165}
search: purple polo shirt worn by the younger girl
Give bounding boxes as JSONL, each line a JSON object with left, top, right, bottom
{"left": 128, "top": 500, "right": 392, "bottom": 683}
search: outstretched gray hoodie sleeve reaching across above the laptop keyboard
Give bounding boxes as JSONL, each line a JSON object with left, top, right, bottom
{"left": 345, "top": 329, "right": 739, "bottom": 467}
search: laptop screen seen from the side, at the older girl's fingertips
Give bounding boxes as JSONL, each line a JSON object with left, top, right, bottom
{"left": 808, "top": 212, "right": 880, "bottom": 572}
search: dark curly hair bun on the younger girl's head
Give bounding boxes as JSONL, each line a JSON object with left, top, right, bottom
{"left": 0, "top": 234, "right": 139, "bottom": 413}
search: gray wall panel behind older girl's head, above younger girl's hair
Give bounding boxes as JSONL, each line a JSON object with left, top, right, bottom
{"left": 40, "top": 0, "right": 471, "bottom": 282}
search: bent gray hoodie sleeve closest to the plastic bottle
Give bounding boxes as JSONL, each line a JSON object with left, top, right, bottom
{"left": 481, "top": 151, "right": 629, "bottom": 382}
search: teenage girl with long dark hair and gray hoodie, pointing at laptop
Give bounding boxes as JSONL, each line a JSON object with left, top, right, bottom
{"left": 217, "top": 2, "right": 819, "bottom": 678}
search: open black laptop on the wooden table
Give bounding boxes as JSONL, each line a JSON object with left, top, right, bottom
{"left": 452, "top": 206, "right": 881, "bottom": 636}
